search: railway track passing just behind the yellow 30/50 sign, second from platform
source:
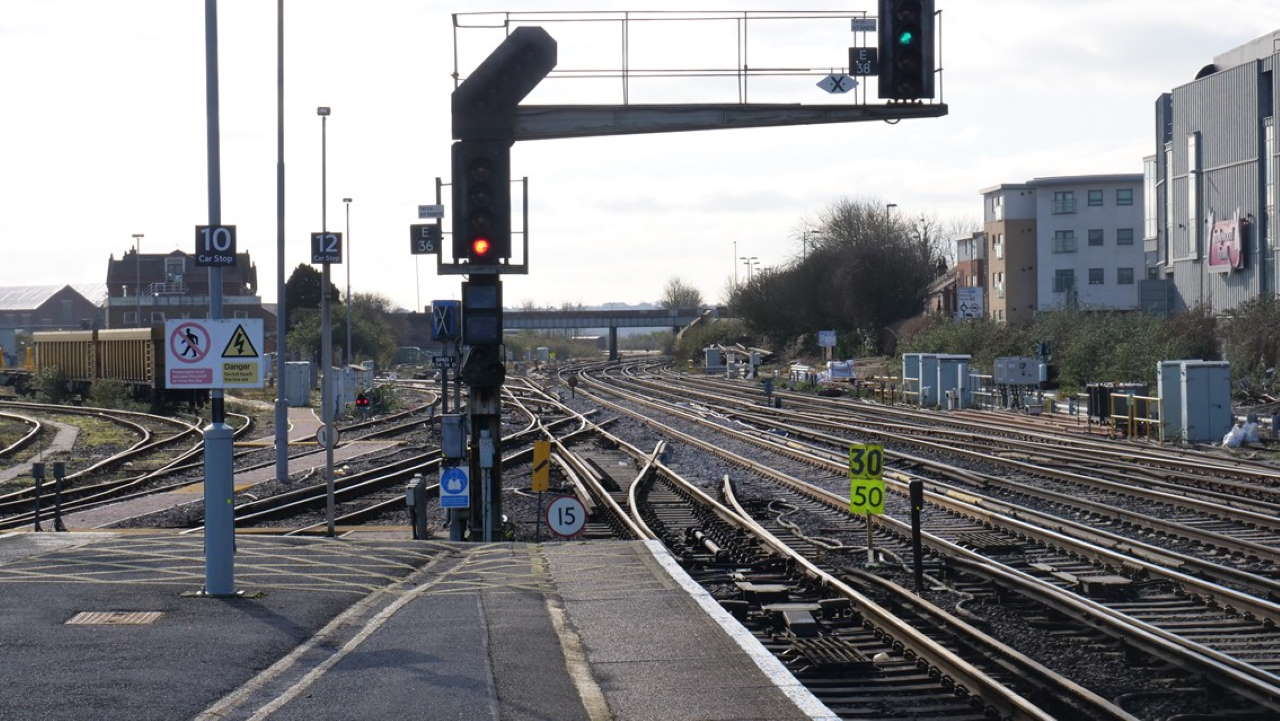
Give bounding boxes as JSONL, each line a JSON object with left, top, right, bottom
{"left": 570, "top": 366, "right": 1280, "bottom": 717}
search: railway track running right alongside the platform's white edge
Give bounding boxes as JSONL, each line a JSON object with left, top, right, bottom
{"left": 519, "top": 379, "right": 1134, "bottom": 721}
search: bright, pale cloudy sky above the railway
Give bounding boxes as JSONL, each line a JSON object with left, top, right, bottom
{"left": 0, "top": 0, "right": 1280, "bottom": 307}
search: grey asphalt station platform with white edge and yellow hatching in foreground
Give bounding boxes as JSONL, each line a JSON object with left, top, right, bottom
{"left": 0, "top": 531, "right": 836, "bottom": 721}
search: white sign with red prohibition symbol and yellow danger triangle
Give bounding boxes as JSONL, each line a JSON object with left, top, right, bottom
{"left": 164, "top": 318, "right": 264, "bottom": 388}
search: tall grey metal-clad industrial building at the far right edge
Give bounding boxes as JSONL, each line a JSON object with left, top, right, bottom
{"left": 1142, "top": 31, "right": 1280, "bottom": 314}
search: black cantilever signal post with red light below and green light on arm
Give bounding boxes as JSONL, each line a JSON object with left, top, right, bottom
{"left": 440, "top": 0, "right": 947, "bottom": 535}
